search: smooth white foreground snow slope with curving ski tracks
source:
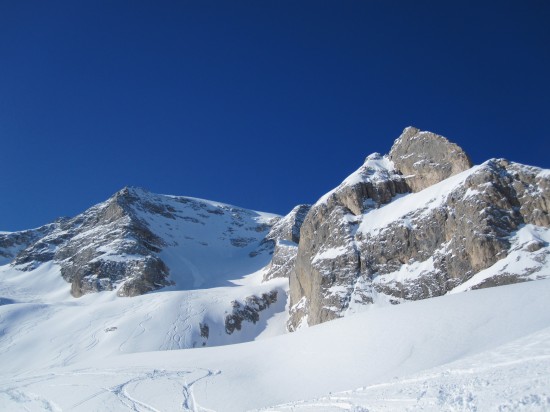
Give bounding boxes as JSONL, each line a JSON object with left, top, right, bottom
{"left": 0, "top": 280, "right": 550, "bottom": 411}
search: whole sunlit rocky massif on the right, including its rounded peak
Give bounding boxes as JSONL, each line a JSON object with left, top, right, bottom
{"left": 288, "top": 128, "right": 550, "bottom": 330}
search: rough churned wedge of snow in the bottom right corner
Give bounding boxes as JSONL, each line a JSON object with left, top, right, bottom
{"left": 270, "top": 328, "right": 550, "bottom": 412}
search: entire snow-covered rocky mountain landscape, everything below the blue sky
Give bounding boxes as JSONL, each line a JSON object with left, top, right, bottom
{"left": 0, "top": 128, "right": 550, "bottom": 411}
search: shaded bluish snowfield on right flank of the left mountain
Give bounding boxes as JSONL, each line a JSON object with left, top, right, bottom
{"left": 128, "top": 191, "right": 279, "bottom": 290}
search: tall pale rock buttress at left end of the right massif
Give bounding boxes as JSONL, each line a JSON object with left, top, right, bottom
{"left": 289, "top": 153, "right": 409, "bottom": 330}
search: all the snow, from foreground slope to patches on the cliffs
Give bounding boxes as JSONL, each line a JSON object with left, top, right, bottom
{"left": 0, "top": 182, "right": 550, "bottom": 412}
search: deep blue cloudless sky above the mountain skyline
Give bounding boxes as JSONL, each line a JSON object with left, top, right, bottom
{"left": 0, "top": 0, "right": 550, "bottom": 230}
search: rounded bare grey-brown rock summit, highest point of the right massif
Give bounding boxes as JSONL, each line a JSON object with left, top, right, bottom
{"left": 389, "top": 127, "right": 472, "bottom": 192}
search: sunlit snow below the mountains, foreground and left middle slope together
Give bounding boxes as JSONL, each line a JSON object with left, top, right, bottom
{"left": 0, "top": 267, "right": 550, "bottom": 411}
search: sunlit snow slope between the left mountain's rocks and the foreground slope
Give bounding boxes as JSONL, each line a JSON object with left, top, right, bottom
{"left": 0, "top": 264, "right": 288, "bottom": 373}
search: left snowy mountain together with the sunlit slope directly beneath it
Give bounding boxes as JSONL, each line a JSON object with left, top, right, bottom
{"left": 0, "top": 188, "right": 294, "bottom": 366}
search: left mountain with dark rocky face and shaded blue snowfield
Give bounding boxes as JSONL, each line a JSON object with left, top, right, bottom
{"left": 4, "top": 188, "right": 278, "bottom": 297}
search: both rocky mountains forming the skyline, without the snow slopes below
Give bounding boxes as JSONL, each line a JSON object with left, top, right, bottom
{"left": 0, "top": 127, "right": 550, "bottom": 331}
